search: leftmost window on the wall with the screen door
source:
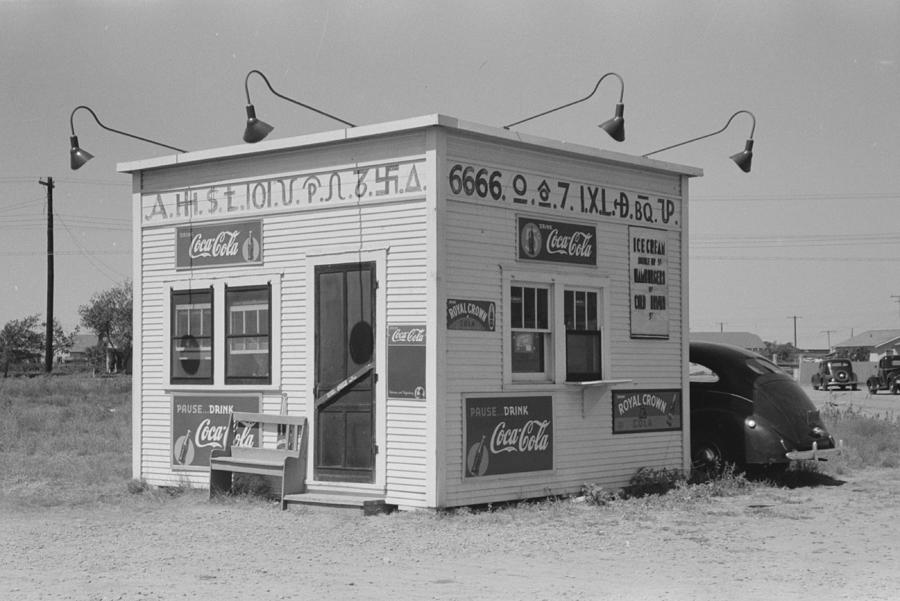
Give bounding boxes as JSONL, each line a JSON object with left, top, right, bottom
{"left": 171, "top": 288, "right": 213, "bottom": 384}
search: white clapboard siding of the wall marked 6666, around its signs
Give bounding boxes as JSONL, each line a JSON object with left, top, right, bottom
{"left": 438, "top": 136, "right": 687, "bottom": 506}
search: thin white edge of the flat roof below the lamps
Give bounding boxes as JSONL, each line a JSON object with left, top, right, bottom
{"left": 116, "top": 114, "right": 703, "bottom": 177}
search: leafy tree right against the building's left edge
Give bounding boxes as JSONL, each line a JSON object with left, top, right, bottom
{"left": 78, "top": 280, "right": 133, "bottom": 371}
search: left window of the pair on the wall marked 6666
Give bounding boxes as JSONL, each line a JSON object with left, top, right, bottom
{"left": 510, "top": 286, "right": 552, "bottom": 379}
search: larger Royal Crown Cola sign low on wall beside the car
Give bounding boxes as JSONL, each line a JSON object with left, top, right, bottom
{"left": 612, "top": 390, "right": 682, "bottom": 434}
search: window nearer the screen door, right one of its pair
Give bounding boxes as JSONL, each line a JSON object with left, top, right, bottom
{"left": 225, "top": 285, "right": 272, "bottom": 384}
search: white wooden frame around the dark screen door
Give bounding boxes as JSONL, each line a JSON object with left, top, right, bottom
{"left": 304, "top": 247, "right": 388, "bottom": 491}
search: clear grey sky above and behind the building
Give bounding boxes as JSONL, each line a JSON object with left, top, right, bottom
{"left": 0, "top": 0, "right": 900, "bottom": 348}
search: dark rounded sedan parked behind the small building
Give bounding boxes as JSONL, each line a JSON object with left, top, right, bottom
{"left": 690, "top": 342, "right": 840, "bottom": 471}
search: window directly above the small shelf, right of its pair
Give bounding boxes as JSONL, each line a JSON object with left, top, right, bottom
{"left": 563, "top": 290, "right": 603, "bottom": 382}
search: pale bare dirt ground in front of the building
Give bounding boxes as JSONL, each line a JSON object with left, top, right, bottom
{"left": 0, "top": 469, "right": 900, "bottom": 601}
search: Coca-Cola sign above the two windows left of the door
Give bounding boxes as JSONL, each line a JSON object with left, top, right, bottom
{"left": 175, "top": 220, "right": 262, "bottom": 269}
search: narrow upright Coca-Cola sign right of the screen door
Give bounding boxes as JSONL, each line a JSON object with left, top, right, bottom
{"left": 388, "top": 324, "right": 425, "bottom": 399}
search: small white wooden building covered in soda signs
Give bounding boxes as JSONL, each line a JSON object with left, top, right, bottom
{"left": 119, "top": 115, "right": 701, "bottom": 508}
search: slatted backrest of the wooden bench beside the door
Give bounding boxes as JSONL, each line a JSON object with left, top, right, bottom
{"left": 225, "top": 411, "right": 306, "bottom": 458}
